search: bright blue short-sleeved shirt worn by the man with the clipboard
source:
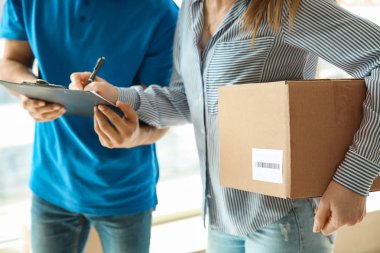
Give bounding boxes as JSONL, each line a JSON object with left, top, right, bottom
{"left": 0, "top": 0, "right": 178, "bottom": 216}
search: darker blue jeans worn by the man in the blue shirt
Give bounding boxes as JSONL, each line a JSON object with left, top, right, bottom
{"left": 32, "top": 196, "right": 152, "bottom": 253}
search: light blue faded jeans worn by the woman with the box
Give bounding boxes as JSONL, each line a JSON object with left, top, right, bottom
{"left": 207, "top": 199, "right": 333, "bottom": 253}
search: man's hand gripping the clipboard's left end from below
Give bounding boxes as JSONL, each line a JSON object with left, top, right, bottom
{"left": 20, "top": 95, "right": 66, "bottom": 122}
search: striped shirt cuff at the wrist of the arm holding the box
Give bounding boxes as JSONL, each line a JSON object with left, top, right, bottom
{"left": 333, "top": 150, "right": 380, "bottom": 196}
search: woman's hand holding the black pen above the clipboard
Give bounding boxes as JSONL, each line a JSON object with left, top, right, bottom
{"left": 69, "top": 72, "right": 118, "bottom": 104}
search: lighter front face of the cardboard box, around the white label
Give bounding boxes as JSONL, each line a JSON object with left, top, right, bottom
{"left": 219, "top": 82, "right": 289, "bottom": 195}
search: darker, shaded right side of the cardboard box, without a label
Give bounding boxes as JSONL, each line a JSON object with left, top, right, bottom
{"left": 289, "top": 80, "right": 365, "bottom": 198}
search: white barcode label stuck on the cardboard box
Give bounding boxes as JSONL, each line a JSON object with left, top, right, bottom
{"left": 252, "top": 148, "right": 284, "bottom": 184}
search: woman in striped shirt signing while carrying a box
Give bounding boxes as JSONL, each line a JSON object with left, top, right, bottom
{"left": 72, "top": 0, "right": 380, "bottom": 253}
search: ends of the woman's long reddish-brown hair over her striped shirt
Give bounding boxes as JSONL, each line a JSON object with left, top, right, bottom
{"left": 243, "top": 0, "right": 302, "bottom": 41}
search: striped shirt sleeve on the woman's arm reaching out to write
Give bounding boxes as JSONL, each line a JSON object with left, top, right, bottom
{"left": 117, "top": 4, "right": 191, "bottom": 128}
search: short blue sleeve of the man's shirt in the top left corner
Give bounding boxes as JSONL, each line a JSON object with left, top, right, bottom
{"left": 0, "top": 0, "right": 28, "bottom": 40}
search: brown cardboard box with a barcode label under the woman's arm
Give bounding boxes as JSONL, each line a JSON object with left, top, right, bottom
{"left": 219, "top": 80, "right": 380, "bottom": 198}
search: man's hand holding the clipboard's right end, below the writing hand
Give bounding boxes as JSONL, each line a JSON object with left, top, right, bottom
{"left": 94, "top": 101, "right": 142, "bottom": 148}
